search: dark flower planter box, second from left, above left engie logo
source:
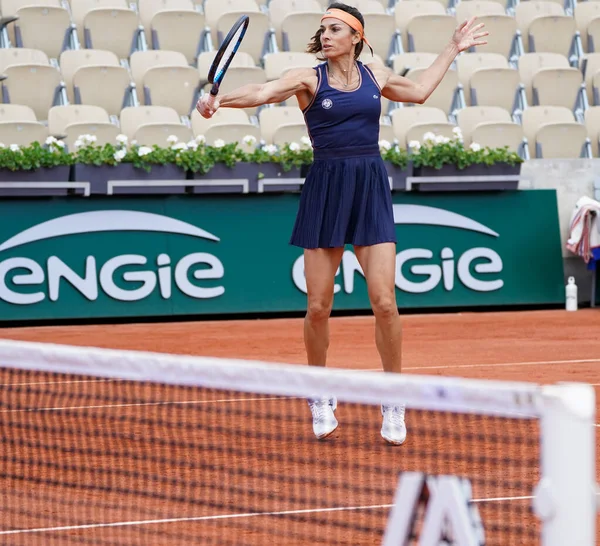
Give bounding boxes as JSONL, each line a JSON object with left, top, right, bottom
{"left": 72, "top": 163, "right": 187, "bottom": 195}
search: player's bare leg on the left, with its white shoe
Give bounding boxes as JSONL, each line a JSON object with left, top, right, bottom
{"left": 304, "top": 248, "right": 344, "bottom": 440}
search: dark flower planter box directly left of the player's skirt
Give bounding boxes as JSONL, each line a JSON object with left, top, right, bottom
{"left": 192, "top": 162, "right": 303, "bottom": 193}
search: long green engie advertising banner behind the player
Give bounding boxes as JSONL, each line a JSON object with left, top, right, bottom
{"left": 0, "top": 190, "right": 564, "bottom": 321}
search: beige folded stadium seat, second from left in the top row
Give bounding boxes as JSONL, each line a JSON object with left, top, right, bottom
{"left": 83, "top": 8, "right": 140, "bottom": 59}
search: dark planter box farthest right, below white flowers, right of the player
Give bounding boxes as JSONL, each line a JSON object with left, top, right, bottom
{"left": 411, "top": 163, "right": 521, "bottom": 191}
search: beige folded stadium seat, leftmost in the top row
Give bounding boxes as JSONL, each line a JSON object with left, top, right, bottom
{"left": 14, "top": 4, "right": 75, "bottom": 59}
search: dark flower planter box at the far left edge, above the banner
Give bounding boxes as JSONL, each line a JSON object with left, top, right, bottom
{"left": 0, "top": 165, "right": 76, "bottom": 197}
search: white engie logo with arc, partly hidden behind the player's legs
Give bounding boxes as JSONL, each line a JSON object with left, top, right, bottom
{"left": 292, "top": 205, "right": 504, "bottom": 294}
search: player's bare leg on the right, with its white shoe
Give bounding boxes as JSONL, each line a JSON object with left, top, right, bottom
{"left": 355, "top": 243, "right": 406, "bottom": 445}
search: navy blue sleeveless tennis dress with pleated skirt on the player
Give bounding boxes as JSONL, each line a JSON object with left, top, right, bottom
{"left": 290, "top": 61, "right": 396, "bottom": 248}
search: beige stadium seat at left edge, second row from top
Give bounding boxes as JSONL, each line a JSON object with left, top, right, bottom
{"left": 0, "top": 48, "right": 63, "bottom": 121}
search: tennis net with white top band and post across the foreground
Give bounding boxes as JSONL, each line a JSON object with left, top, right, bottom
{"left": 0, "top": 341, "right": 595, "bottom": 546}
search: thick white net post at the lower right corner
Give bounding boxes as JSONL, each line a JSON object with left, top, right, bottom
{"left": 533, "top": 383, "right": 597, "bottom": 546}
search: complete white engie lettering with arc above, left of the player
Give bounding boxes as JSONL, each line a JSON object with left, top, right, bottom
{"left": 0, "top": 210, "right": 225, "bottom": 305}
